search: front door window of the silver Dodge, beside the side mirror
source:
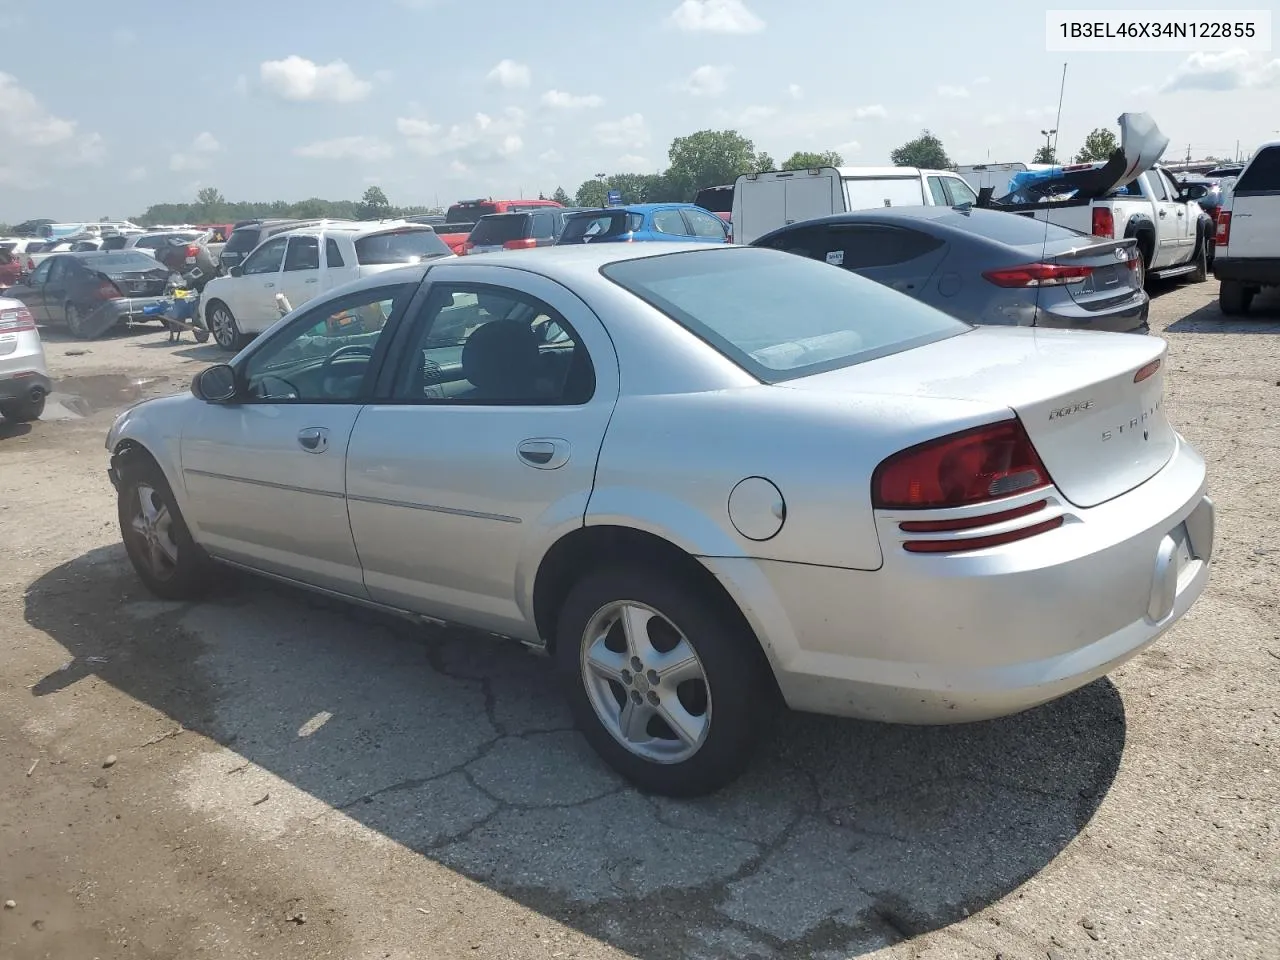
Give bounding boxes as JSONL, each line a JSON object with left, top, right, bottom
{"left": 239, "top": 284, "right": 416, "bottom": 403}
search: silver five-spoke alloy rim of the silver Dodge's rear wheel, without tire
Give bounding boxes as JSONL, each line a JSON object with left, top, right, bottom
{"left": 580, "top": 600, "right": 712, "bottom": 764}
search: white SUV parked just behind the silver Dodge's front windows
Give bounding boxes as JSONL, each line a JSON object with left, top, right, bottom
{"left": 200, "top": 220, "right": 453, "bottom": 349}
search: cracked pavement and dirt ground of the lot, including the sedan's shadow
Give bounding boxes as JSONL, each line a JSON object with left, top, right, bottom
{"left": 0, "top": 282, "right": 1280, "bottom": 960}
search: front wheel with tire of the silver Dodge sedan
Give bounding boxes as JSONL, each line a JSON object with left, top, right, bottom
{"left": 116, "top": 453, "right": 212, "bottom": 600}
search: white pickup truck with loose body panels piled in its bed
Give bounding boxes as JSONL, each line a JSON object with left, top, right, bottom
{"left": 979, "top": 114, "right": 1215, "bottom": 282}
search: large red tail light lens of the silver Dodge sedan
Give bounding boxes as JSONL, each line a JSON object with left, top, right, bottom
{"left": 872, "top": 420, "right": 1052, "bottom": 509}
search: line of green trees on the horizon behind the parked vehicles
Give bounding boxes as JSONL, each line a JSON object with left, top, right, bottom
{"left": 110, "top": 127, "right": 1146, "bottom": 225}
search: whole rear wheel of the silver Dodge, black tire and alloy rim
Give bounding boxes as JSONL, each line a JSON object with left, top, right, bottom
{"left": 556, "top": 566, "right": 777, "bottom": 797}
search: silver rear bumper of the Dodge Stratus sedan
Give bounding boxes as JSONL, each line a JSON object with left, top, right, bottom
{"left": 703, "top": 439, "right": 1213, "bottom": 724}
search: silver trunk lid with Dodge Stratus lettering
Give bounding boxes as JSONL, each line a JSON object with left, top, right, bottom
{"left": 786, "top": 328, "right": 1178, "bottom": 507}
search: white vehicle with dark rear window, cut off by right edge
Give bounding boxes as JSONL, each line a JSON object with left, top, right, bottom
{"left": 1213, "top": 140, "right": 1280, "bottom": 315}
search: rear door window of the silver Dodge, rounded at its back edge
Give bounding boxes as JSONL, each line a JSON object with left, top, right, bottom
{"left": 393, "top": 283, "right": 595, "bottom": 406}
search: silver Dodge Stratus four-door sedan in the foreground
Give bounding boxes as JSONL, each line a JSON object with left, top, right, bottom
{"left": 106, "top": 244, "right": 1213, "bottom": 795}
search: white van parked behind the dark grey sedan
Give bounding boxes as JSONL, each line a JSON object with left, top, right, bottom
{"left": 733, "top": 166, "right": 978, "bottom": 243}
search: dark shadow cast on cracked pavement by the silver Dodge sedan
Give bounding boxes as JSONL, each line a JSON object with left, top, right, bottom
{"left": 26, "top": 547, "right": 1126, "bottom": 957}
